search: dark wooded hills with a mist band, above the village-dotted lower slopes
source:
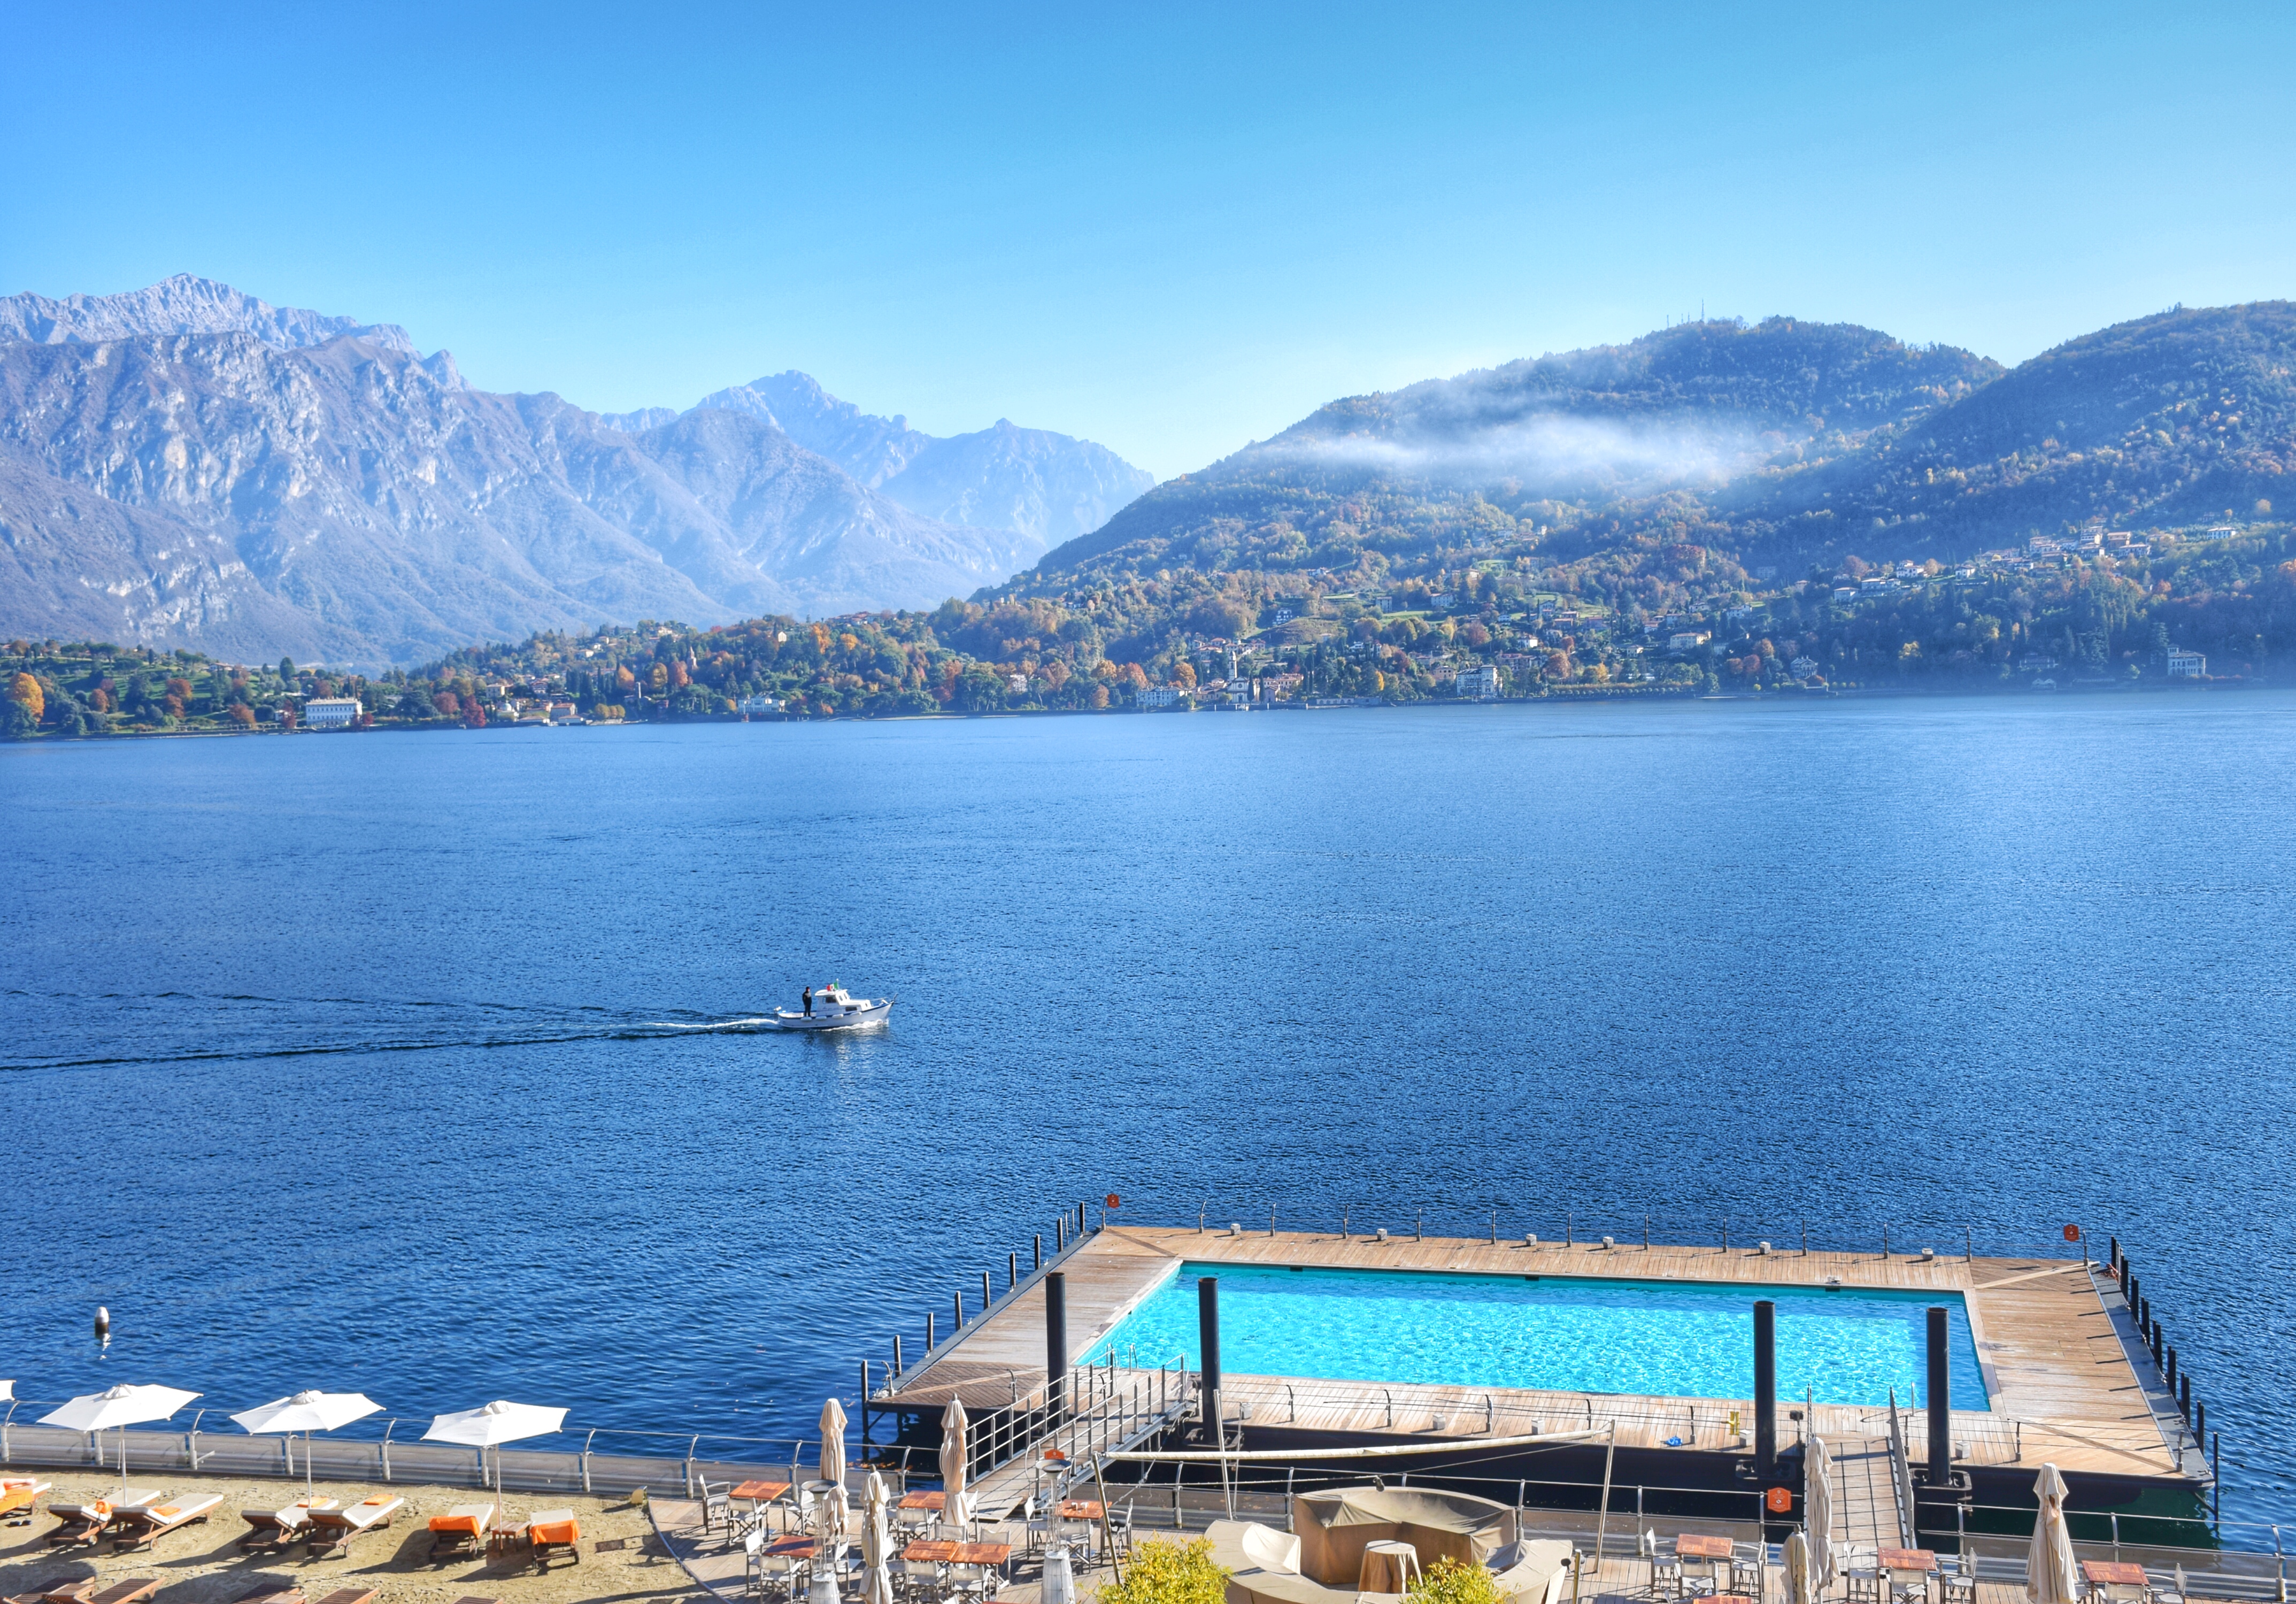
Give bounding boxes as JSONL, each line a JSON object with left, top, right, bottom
{"left": 1028, "top": 300, "right": 2296, "bottom": 592}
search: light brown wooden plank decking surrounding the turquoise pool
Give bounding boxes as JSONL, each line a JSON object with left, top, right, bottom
{"left": 877, "top": 1225, "right": 2200, "bottom": 1478}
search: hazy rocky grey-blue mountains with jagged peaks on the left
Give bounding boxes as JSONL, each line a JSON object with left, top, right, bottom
{"left": 0, "top": 275, "right": 1146, "bottom": 666}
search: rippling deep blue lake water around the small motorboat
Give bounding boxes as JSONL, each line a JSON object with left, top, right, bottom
{"left": 0, "top": 693, "right": 2296, "bottom": 1519}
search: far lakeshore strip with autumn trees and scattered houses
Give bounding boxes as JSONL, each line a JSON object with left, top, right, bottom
{"left": 0, "top": 514, "right": 2296, "bottom": 739}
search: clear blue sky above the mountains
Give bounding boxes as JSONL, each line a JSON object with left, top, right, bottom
{"left": 0, "top": 0, "right": 2296, "bottom": 475}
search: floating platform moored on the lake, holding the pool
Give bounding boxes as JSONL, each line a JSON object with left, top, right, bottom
{"left": 870, "top": 1225, "right": 2211, "bottom": 1535}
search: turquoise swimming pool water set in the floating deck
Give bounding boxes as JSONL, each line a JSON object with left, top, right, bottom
{"left": 1091, "top": 1264, "right": 1991, "bottom": 1409}
